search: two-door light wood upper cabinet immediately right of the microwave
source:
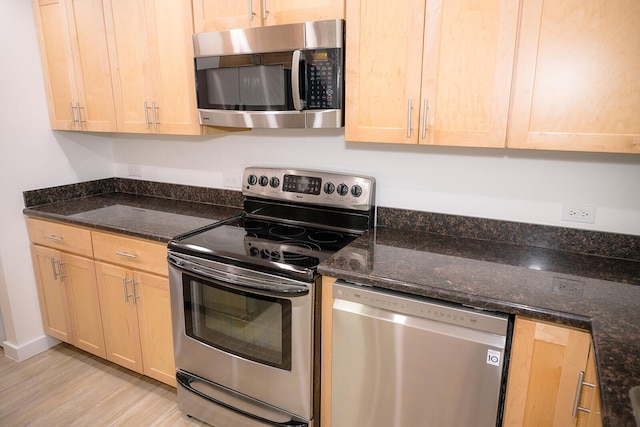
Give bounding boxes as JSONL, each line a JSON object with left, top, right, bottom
{"left": 345, "top": 0, "right": 518, "bottom": 147}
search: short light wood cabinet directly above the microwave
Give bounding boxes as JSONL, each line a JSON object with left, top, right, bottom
{"left": 193, "top": 0, "right": 345, "bottom": 33}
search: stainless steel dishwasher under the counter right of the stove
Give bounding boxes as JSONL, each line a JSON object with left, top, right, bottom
{"left": 330, "top": 281, "right": 511, "bottom": 427}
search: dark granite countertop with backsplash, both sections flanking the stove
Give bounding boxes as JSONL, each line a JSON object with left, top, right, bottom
{"left": 23, "top": 178, "right": 640, "bottom": 427}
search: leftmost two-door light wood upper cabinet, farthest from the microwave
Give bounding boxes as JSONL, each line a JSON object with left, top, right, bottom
{"left": 33, "top": 0, "right": 116, "bottom": 132}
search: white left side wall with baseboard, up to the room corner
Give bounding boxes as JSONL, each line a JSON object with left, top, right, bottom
{"left": 0, "top": 0, "right": 114, "bottom": 359}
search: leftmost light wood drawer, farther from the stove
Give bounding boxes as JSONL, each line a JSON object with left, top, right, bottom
{"left": 27, "top": 218, "right": 93, "bottom": 257}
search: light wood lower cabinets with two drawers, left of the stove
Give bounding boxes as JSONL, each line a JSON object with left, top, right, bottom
{"left": 27, "top": 218, "right": 176, "bottom": 387}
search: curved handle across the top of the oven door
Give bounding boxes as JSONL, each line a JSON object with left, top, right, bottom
{"left": 167, "top": 255, "right": 309, "bottom": 297}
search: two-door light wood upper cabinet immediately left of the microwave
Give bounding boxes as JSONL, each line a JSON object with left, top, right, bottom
{"left": 104, "top": 0, "right": 201, "bottom": 135}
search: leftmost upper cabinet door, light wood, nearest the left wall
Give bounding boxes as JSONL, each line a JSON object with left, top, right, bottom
{"left": 33, "top": 0, "right": 78, "bottom": 130}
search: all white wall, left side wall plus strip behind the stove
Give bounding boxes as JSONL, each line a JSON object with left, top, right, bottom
{"left": 0, "top": 0, "right": 640, "bottom": 358}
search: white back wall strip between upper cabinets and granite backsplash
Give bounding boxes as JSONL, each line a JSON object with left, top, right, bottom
{"left": 114, "top": 130, "right": 640, "bottom": 235}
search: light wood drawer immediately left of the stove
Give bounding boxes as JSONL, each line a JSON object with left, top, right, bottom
{"left": 91, "top": 231, "right": 168, "bottom": 276}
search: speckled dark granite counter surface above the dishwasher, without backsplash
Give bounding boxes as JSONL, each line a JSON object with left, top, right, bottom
{"left": 319, "top": 226, "right": 640, "bottom": 427}
